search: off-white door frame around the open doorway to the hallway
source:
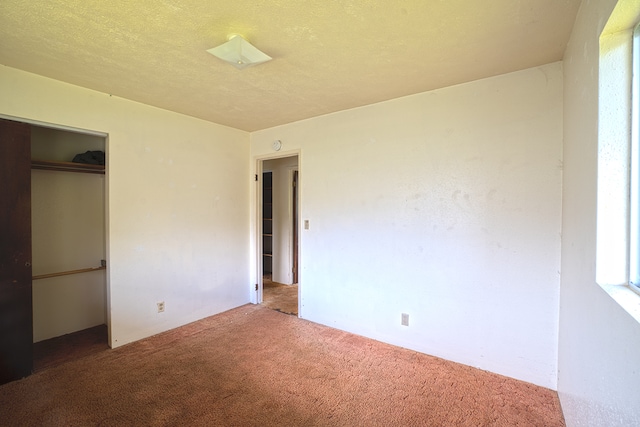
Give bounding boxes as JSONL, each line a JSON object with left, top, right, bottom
{"left": 250, "top": 149, "right": 303, "bottom": 318}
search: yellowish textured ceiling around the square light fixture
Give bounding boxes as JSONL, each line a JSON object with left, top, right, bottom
{"left": 0, "top": 0, "right": 580, "bottom": 131}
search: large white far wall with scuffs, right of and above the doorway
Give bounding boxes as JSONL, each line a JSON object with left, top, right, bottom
{"left": 251, "top": 63, "right": 563, "bottom": 389}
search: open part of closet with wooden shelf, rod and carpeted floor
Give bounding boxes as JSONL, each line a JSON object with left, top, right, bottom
{"left": 31, "top": 125, "right": 109, "bottom": 371}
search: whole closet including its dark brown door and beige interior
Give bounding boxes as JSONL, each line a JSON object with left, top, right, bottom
{"left": 0, "top": 120, "right": 107, "bottom": 383}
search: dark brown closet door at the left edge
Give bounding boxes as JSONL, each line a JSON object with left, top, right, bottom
{"left": 0, "top": 119, "right": 33, "bottom": 384}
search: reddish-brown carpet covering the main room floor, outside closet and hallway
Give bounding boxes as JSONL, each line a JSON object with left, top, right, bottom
{"left": 0, "top": 305, "right": 564, "bottom": 426}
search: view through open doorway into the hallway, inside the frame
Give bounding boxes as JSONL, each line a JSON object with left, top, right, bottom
{"left": 259, "top": 156, "right": 299, "bottom": 316}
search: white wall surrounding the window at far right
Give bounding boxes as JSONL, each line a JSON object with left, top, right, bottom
{"left": 558, "top": 0, "right": 640, "bottom": 426}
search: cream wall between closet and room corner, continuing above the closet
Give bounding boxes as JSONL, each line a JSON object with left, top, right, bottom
{"left": 0, "top": 66, "right": 250, "bottom": 347}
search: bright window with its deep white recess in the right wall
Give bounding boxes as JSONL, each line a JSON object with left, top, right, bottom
{"left": 596, "top": 0, "right": 640, "bottom": 322}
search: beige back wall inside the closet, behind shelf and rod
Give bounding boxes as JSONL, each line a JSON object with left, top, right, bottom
{"left": 31, "top": 126, "right": 107, "bottom": 342}
